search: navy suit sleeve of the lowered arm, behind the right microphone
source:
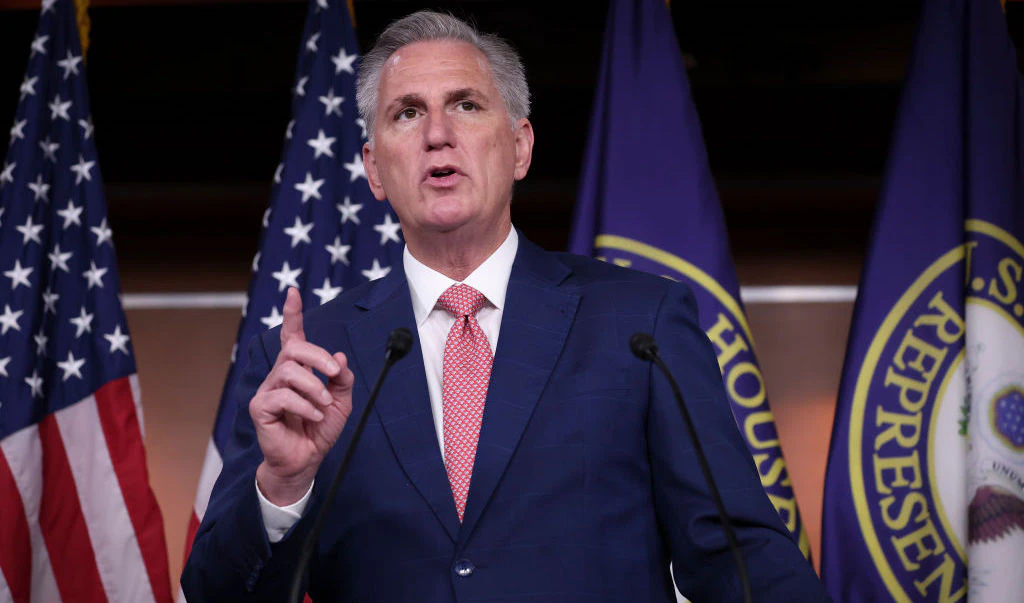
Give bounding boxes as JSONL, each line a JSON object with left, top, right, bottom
{"left": 647, "top": 284, "right": 828, "bottom": 603}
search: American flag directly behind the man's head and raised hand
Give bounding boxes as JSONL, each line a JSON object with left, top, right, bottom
{"left": 178, "top": 0, "right": 402, "bottom": 593}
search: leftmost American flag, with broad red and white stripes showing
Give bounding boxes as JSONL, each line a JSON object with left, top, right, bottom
{"left": 0, "top": 0, "right": 171, "bottom": 603}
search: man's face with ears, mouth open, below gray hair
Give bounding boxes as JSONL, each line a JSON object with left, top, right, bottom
{"left": 362, "top": 41, "right": 534, "bottom": 239}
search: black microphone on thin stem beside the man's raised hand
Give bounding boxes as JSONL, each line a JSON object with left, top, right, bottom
{"left": 288, "top": 327, "right": 413, "bottom": 603}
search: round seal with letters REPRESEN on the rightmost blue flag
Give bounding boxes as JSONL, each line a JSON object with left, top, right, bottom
{"left": 849, "top": 220, "right": 1024, "bottom": 603}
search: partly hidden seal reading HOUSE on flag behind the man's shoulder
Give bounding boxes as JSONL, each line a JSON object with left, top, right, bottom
{"left": 594, "top": 234, "right": 811, "bottom": 557}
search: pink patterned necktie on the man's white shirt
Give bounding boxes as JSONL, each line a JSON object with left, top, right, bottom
{"left": 437, "top": 285, "right": 494, "bottom": 522}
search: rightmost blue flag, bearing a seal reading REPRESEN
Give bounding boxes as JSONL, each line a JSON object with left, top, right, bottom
{"left": 821, "top": 0, "right": 1024, "bottom": 602}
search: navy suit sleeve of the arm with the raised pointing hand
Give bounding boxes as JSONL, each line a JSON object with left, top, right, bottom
{"left": 181, "top": 336, "right": 317, "bottom": 603}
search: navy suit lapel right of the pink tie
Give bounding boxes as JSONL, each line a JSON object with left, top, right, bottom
{"left": 460, "top": 234, "right": 580, "bottom": 548}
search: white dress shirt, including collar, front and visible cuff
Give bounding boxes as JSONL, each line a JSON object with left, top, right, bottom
{"left": 256, "top": 228, "right": 519, "bottom": 543}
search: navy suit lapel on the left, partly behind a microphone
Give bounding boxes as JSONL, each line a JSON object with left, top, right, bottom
{"left": 348, "top": 262, "right": 459, "bottom": 542}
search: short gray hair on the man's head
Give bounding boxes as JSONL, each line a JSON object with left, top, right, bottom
{"left": 355, "top": 10, "right": 529, "bottom": 143}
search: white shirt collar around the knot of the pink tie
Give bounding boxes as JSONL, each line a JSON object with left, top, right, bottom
{"left": 401, "top": 228, "right": 519, "bottom": 327}
